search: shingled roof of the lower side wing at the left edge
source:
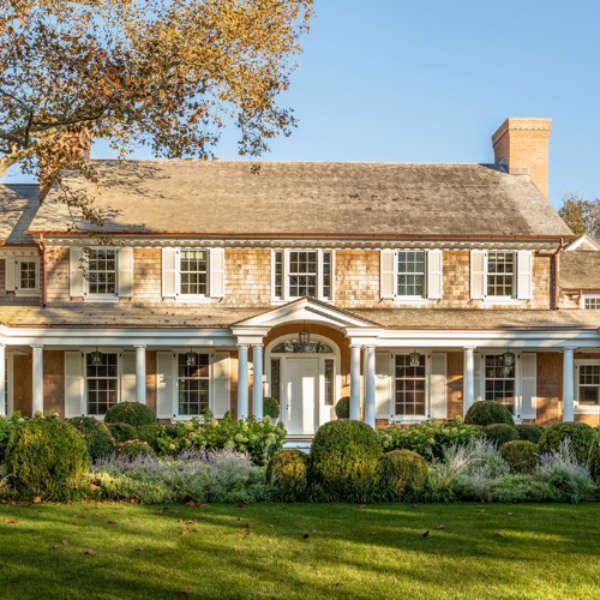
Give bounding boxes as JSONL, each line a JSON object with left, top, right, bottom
{"left": 0, "top": 183, "right": 40, "bottom": 244}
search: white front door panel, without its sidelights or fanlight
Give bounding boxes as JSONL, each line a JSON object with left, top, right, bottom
{"left": 283, "top": 357, "right": 319, "bottom": 435}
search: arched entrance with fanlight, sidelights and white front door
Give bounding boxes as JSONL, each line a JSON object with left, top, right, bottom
{"left": 265, "top": 333, "right": 341, "bottom": 436}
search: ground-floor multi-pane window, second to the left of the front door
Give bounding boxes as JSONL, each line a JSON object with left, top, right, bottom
{"left": 86, "top": 352, "right": 119, "bottom": 416}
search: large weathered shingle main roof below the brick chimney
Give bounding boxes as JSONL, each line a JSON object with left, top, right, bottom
{"left": 31, "top": 160, "right": 571, "bottom": 237}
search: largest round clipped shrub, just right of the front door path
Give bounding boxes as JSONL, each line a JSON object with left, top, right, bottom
{"left": 310, "top": 420, "right": 382, "bottom": 502}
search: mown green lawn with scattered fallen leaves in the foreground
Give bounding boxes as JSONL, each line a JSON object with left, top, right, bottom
{"left": 0, "top": 504, "right": 600, "bottom": 600}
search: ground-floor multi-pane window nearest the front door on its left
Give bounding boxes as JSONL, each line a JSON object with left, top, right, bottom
{"left": 177, "top": 352, "right": 210, "bottom": 416}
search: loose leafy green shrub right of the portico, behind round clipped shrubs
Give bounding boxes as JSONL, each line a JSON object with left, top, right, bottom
{"left": 377, "top": 419, "right": 481, "bottom": 460}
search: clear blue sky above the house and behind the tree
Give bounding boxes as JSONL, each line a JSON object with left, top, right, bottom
{"left": 4, "top": 0, "right": 600, "bottom": 211}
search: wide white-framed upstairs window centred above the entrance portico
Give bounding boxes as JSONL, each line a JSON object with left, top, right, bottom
{"left": 271, "top": 250, "right": 334, "bottom": 301}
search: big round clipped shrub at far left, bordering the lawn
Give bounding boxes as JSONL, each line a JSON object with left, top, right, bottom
{"left": 6, "top": 417, "right": 90, "bottom": 501}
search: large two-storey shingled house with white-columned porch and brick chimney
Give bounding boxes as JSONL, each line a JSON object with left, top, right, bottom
{"left": 0, "top": 118, "right": 600, "bottom": 439}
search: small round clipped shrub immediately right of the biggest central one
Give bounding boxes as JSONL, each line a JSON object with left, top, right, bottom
{"left": 381, "top": 450, "right": 429, "bottom": 500}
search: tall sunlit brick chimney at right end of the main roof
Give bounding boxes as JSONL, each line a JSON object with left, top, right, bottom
{"left": 492, "top": 117, "right": 552, "bottom": 199}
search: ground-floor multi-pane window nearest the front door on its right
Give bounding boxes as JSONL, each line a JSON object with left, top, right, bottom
{"left": 395, "top": 354, "right": 426, "bottom": 417}
